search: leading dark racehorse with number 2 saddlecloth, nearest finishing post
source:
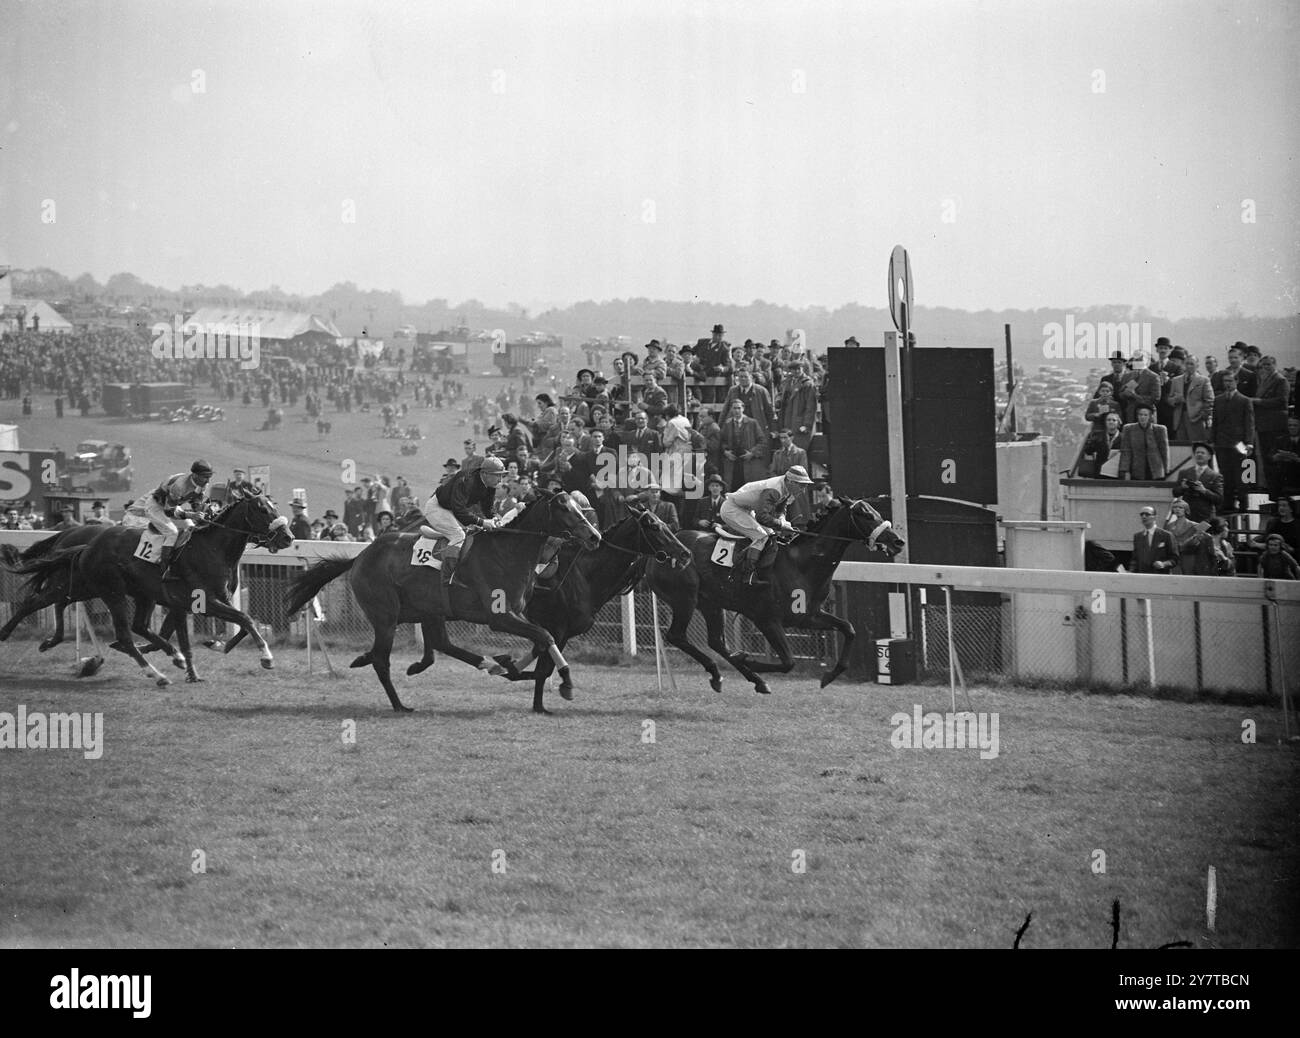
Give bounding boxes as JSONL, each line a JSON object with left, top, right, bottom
{"left": 646, "top": 499, "right": 904, "bottom": 695}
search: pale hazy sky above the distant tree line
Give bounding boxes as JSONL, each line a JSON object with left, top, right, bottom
{"left": 0, "top": 0, "right": 1300, "bottom": 320}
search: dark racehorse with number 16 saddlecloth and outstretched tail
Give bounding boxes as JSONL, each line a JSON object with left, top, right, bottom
{"left": 286, "top": 490, "right": 601, "bottom": 713}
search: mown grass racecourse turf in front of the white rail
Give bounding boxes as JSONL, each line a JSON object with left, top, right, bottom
{"left": 0, "top": 643, "right": 1300, "bottom": 948}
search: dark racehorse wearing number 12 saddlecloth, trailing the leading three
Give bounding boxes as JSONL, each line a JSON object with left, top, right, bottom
{"left": 4, "top": 494, "right": 294, "bottom": 687}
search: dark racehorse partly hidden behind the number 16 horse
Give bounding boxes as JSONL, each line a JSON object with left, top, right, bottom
{"left": 407, "top": 509, "right": 690, "bottom": 714}
